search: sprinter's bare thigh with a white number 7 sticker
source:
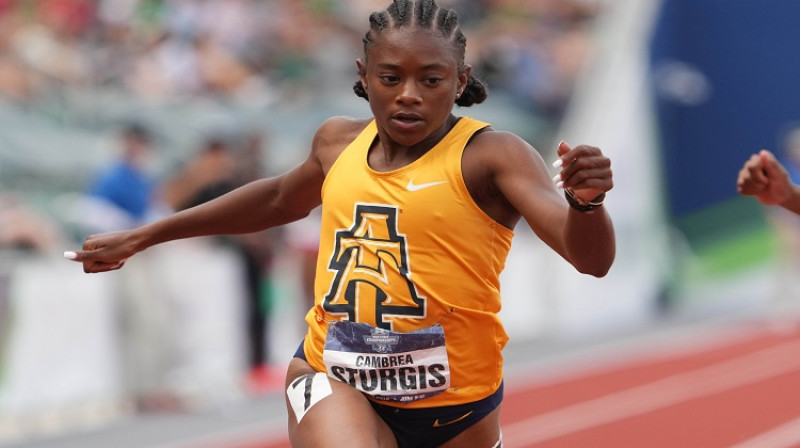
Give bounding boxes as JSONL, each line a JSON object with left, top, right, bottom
{"left": 285, "top": 358, "right": 397, "bottom": 448}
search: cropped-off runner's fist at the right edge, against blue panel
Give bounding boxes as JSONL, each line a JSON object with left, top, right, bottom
{"left": 736, "top": 149, "right": 792, "bottom": 205}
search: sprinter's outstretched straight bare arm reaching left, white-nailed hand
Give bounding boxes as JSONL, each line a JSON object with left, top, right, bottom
{"left": 65, "top": 118, "right": 356, "bottom": 273}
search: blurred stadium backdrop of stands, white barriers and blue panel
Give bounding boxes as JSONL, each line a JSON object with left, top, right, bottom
{"left": 0, "top": 0, "right": 800, "bottom": 446}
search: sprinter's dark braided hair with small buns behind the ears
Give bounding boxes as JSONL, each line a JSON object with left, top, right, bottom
{"left": 353, "top": 0, "right": 489, "bottom": 107}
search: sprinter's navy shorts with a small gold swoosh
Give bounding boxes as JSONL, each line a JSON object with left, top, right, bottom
{"left": 294, "top": 343, "right": 503, "bottom": 448}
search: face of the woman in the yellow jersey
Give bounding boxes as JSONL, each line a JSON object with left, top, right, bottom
{"left": 357, "top": 27, "right": 467, "bottom": 147}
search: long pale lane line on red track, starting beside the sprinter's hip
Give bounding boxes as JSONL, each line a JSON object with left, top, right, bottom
{"left": 503, "top": 342, "right": 800, "bottom": 446}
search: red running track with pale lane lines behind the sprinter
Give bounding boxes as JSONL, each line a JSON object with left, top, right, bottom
{"left": 212, "top": 324, "right": 800, "bottom": 448}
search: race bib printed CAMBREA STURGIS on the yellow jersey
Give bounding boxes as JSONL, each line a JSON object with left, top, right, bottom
{"left": 322, "top": 320, "right": 450, "bottom": 403}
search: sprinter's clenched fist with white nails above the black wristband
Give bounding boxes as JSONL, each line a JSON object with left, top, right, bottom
{"left": 558, "top": 142, "right": 614, "bottom": 201}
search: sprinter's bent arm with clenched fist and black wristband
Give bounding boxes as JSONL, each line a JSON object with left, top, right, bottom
{"left": 490, "top": 132, "right": 616, "bottom": 277}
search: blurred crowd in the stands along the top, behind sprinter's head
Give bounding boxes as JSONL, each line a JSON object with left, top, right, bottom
{"left": 0, "top": 0, "right": 601, "bottom": 117}
